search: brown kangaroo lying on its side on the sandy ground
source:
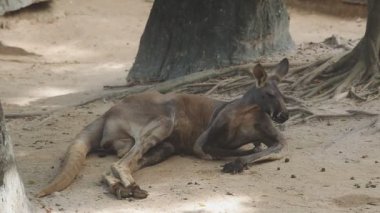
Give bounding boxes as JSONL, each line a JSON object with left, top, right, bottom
{"left": 37, "top": 59, "right": 289, "bottom": 199}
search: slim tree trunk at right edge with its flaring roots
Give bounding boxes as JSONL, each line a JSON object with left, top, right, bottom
{"left": 294, "top": 0, "right": 380, "bottom": 98}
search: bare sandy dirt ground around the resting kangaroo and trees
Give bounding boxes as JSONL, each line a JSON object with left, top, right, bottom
{"left": 0, "top": 0, "right": 380, "bottom": 212}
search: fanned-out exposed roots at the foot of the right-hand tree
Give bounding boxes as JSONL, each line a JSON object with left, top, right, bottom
{"left": 292, "top": 48, "right": 380, "bottom": 99}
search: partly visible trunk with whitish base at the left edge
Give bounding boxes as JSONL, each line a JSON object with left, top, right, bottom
{"left": 0, "top": 103, "right": 31, "bottom": 213}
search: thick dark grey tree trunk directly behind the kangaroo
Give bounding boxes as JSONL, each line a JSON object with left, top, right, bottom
{"left": 127, "top": 0, "right": 294, "bottom": 83}
